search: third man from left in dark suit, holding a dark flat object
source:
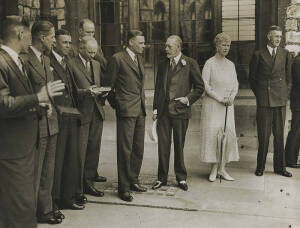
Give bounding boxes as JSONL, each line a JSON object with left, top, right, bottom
{"left": 49, "top": 29, "right": 84, "bottom": 218}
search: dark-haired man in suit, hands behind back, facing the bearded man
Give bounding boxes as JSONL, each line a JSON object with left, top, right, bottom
{"left": 105, "top": 30, "right": 147, "bottom": 201}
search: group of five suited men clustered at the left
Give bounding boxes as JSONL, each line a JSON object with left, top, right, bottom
{"left": 0, "top": 16, "right": 106, "bottom": 227}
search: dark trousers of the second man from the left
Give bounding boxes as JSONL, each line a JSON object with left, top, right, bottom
{"left": 35, "top": 135, "right": 57, "bottom": 216}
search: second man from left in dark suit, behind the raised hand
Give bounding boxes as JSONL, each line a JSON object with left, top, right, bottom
{"left": 24, "top": 21, "right": 62, "bottom": 224}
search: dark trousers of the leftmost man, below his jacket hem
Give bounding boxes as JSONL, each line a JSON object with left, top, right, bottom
{"left": 0, "top": 148, "right": 37, "bottom": 228}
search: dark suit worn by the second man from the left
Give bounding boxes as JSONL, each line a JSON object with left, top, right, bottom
{"left": 23, "top": 47, "right": 58, "bottom": 217}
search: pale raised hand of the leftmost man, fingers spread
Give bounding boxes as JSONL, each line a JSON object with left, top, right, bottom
{"left": 37, "top": 80, "right": 65, "bottom": 103}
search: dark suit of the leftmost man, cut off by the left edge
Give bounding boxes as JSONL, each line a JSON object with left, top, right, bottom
{"left": 0, "top": 46, "right": 38, "bottom": 228}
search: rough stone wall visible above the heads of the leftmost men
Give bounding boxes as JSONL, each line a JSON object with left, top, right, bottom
{"left": 18, "top": 0, "right": 66, "bottom": 29}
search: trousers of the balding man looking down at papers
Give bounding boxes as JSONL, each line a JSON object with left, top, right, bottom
{"left": 77, "top": 110, "right": 103, "bottom": 193}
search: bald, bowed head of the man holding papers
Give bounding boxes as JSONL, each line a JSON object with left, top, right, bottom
{"left": 79, "top": 36, "right": 98, "bottom": 61}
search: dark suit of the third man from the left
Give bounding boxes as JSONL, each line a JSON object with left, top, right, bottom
{"left": 49, "top": 52, "right": 79, "bottom": 209}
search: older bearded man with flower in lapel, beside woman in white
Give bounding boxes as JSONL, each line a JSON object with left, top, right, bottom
{"left": 152, "top": 35, "right": 204, "bottom": 191}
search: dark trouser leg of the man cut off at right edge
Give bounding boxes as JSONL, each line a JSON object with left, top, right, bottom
{"left": 285, "top": 111, "right": 300, "bottom": 165}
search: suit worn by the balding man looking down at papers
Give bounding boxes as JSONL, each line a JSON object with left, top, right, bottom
{"left": 70, "top": 55, "right": 105, "bottom": 193}
